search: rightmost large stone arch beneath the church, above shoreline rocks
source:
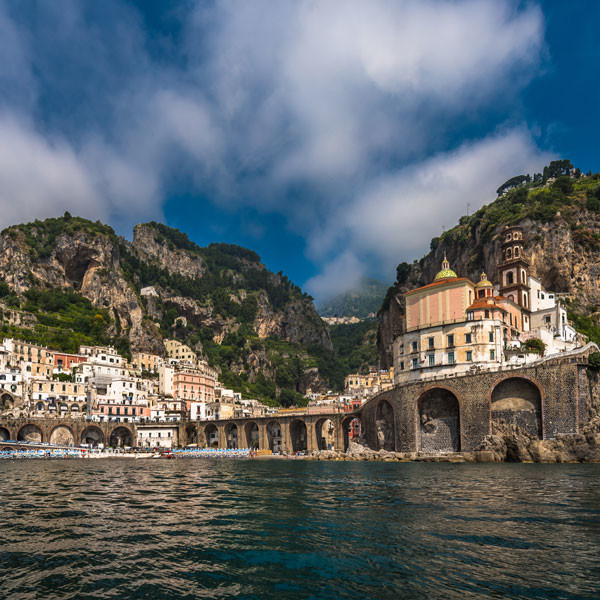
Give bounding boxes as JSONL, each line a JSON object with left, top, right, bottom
{"left": 490, "top": 377, "right": 543, "bottom": 438}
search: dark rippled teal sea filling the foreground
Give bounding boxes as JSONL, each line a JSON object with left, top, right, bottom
{"left": 0, "top": 459, "right": 600, "bottom": 599}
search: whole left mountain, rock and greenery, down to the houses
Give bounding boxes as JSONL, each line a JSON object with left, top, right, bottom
{"left": 0, "top": 214, "right": 332, "bottom": 400}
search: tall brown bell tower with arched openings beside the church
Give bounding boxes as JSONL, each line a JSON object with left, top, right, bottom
{"left": 498, "top": 227, "right": 531, "bottom": 312}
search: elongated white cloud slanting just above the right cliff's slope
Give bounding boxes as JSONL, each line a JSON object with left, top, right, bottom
{"left": 330, "top": 129, "right": 554, "bottom": 272}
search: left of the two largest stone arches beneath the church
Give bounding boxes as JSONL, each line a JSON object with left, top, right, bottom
{"left": 417, "top": 387, "right": 460, "bottom": 454}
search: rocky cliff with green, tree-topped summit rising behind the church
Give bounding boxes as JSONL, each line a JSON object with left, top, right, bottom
{"left": 378, "top": 169, "right": 600, "bottom": 366}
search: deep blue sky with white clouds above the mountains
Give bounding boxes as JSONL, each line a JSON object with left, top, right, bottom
{"left": 0, "top": 0, "right": 600, "bottom": 300}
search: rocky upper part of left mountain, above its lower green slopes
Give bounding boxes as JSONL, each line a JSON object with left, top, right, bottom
{"left": 0, "top": 216, "right": 332, "bottom": 390}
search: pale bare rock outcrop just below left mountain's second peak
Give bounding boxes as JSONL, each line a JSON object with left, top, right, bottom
{"left": 133, "top": 223, "right": 206, "bottom": 278}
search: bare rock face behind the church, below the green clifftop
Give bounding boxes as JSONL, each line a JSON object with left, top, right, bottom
{"left": 378, "top": 210, "right": 600, "bottom": 366}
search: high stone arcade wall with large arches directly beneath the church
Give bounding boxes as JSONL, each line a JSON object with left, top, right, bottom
{"left": 357, "top": 352, "right": 591, "bottom": 454}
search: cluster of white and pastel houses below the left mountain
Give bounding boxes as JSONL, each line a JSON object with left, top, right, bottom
{"left": 0, "top": 338, "right": 274, "bottom": 423}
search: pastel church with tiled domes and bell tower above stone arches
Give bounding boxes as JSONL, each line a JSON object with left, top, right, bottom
{"left": 394, "top": 227, "right": 578, "bottom": 385}
